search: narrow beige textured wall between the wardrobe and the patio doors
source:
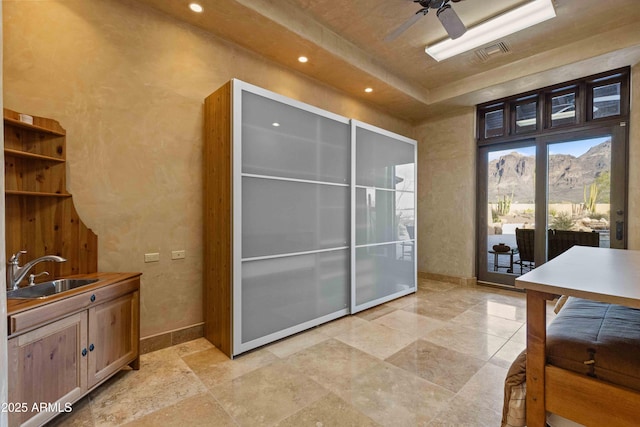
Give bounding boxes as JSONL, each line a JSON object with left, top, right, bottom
{"left": 415, "top": 107, "right": 476, "bottom": 278}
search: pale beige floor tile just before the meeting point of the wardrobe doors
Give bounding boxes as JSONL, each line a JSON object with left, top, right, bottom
{"left": 335, "top": 322, "right": 415, "bottom": 359}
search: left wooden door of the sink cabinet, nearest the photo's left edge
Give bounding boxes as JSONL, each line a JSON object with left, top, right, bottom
{"left": 8, "top": 311, "right": 87, "bottom": 426}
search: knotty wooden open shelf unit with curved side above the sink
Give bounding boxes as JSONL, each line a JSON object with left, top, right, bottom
{"left": 4, "top": 108, "right": 98, "bottom": 279}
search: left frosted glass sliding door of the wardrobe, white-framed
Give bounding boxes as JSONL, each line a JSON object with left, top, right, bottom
{"left": 233, "top": 82, "right": 351, "bottom": 354}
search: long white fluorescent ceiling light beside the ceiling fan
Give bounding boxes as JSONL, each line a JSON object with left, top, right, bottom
{"left": 425, "top": 0, "right": 556, "bottom": 61}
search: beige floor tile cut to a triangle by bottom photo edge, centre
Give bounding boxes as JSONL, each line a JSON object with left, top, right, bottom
{"left": 276, "top": 393, "right": 379, "bottom": 427}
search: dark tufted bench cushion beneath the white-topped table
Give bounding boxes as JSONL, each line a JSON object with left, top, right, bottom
{"left": 547, "top": 297, "right": 640, "bottom": 391}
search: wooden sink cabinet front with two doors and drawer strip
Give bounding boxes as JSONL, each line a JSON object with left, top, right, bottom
{"left": 9, "top": 277, "right": 140, "bottom": 426}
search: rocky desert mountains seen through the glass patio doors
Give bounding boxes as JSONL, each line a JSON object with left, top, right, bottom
{"left": 488, "top": 140, "right": 611, "bottom": 203}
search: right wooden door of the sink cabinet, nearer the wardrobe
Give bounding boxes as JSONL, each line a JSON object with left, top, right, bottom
{"left": 88, "top": 291, "right": 140, "bottom": 388}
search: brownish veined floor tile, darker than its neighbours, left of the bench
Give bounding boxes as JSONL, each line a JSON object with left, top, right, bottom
{"left": 386, "top": 340, "right": 485, "bottom": 393}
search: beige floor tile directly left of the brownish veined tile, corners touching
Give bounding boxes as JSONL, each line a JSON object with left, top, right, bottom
{"left": 285, "top": 339, "right": 383, "bottom": 392}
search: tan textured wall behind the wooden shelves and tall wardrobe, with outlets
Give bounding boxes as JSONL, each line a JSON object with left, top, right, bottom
{"left": 4, "top": 0, "right": 413, "bottom": 337}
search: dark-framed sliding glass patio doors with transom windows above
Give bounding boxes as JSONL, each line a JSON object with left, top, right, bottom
{"left": 476, "top": 67, "right": 631, "bottom": 285}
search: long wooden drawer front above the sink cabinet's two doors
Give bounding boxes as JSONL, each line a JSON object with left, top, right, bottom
{"left": 9, "top": 278, "right": 140, "bottom": 335}
